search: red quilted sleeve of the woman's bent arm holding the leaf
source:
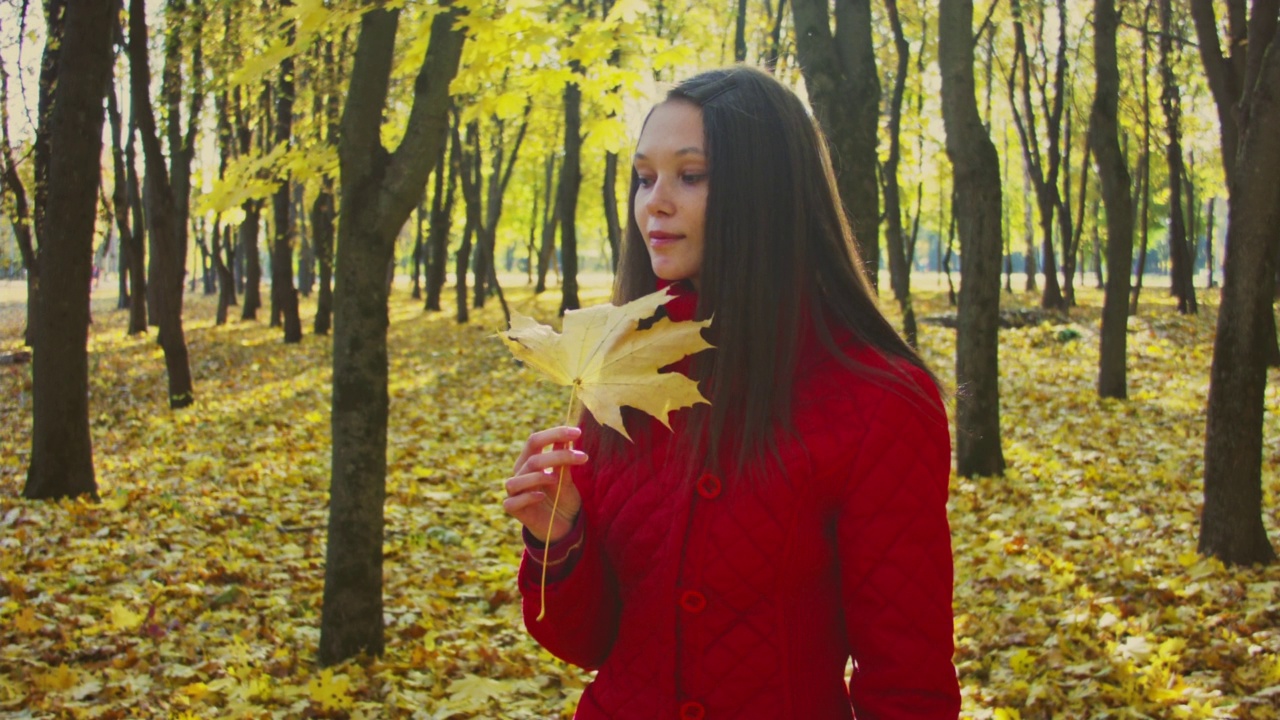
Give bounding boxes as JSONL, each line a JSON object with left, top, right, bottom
{"left": 518, "top": 458, "right": 622, "bottom": 670}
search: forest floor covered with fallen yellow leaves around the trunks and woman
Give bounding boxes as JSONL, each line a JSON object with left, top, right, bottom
{"left": 0, "top": 278, "right": 1280, "bottom": 720}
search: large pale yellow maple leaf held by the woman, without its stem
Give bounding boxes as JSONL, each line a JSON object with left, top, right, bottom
{"left": 502, "top": 284, "right": 712, "bottom": 439}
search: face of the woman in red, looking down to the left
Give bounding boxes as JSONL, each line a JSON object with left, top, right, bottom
{"left": 634, "top": 100, "right": 709, "bottom": 287}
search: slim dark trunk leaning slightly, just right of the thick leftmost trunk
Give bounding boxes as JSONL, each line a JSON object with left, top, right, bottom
{"left": 129, "top": 0, "right": 195, "bottom": 409}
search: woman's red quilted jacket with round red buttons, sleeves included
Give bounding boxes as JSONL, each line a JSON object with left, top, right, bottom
{"left": 520, "top": 283, "right": 960, "bottom": 720}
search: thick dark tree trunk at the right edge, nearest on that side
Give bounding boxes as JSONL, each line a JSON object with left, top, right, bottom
{"left": 1192, "top": 0, "right": 1280, "bottom": 565}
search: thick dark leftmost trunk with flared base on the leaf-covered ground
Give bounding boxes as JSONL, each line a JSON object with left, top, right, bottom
{"left": 22, "top": 0, "right": 118, "bottom": 498}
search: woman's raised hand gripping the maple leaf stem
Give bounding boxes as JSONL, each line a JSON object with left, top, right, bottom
{"left": 502, "top": 427, "right": 586, "bottom": 543}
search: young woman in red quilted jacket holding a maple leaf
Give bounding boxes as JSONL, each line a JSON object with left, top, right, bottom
{"left": 503, "top": 67, "right": 960, "bottom": 720}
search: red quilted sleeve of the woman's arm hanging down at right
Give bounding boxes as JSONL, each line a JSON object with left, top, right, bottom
{"left": 837, "top": 373, "right": 960, "bottom": 720}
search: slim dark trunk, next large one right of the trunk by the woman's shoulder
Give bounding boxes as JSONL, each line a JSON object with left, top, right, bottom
{"left": 1089, "top": 0, "right": 1133, "bottom": 398}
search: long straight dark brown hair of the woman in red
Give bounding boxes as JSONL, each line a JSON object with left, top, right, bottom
{"left": 602, "top": 65, "right": 937, "bottom": 475}
